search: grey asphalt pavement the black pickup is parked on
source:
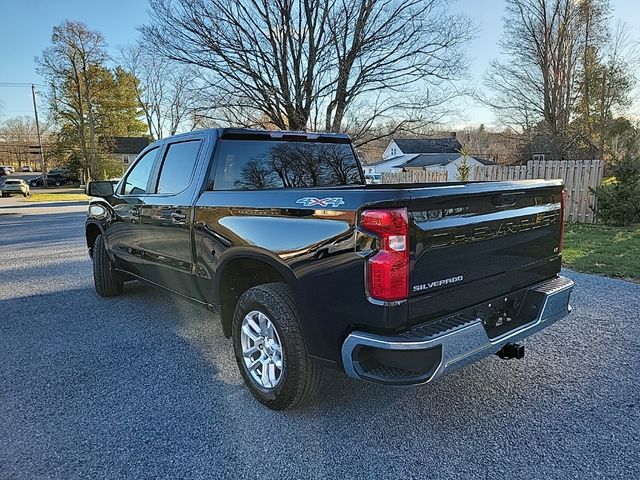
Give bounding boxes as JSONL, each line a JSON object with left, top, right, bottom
{"left": 0, "top": 204, "right": 640, "bottom": 479}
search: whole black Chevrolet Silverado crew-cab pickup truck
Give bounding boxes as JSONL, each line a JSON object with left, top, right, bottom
{"left": 86, "top": 128, "right": 573, "bottom": 409}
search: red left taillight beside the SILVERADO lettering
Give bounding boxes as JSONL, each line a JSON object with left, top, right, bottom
{"left": 360, "top": 208, "right": 409, "bottom": 302}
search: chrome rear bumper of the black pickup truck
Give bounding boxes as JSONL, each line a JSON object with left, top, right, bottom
{"left": 342, "top": 276, "right": 574, "bottom": 385}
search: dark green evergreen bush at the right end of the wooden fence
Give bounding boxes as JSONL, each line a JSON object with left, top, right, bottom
{"left": 595, "top": 155, "right": 640, "bottom": 226}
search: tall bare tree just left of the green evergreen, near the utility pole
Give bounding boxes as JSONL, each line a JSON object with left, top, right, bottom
{"left": 36, "top": 20, "right": 108, "bottom": 178}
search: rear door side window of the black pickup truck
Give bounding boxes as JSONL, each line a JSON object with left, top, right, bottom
{"left": 157, "top": 140, "right": 202, "bottom": 195}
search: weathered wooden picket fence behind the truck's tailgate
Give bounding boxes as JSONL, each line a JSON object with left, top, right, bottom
{"left": 382, "top": 160, "right": 604, "bottom": 223}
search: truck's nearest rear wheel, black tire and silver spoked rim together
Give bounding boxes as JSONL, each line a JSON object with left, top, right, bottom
{"left": 233, "top": 283, "right": 322, "bottom": 410}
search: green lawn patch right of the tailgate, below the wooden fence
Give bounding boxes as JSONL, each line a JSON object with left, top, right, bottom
{"left": 562, "top": 223, "right": 640, "bottom": 282}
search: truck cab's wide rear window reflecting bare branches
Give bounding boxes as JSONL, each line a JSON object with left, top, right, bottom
{"left": 214, "top": 140, "right": 363, "bottom": 190}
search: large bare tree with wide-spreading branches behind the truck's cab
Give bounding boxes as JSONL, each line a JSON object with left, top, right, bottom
{"left": 142, "top": 0, "right": 473, "bottom": 131}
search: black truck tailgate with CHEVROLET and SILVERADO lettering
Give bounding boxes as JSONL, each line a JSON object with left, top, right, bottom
{"left": 408, "top": 180, "right": 562, "bottom": 324}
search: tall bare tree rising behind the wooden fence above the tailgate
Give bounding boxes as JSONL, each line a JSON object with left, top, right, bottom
{"left": 485, "top": 0, "right": 583, "bottom": 136}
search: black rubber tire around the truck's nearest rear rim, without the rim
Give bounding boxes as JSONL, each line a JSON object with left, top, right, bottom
{"left": 233, "top": 283, "right": 322, "bottom": 410}
